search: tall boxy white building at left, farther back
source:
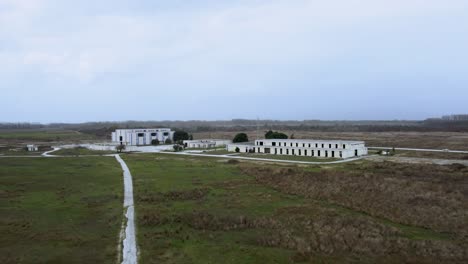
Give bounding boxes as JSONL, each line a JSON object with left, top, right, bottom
{"left": 112, "top": 128, "right": 174, "bottom": 146}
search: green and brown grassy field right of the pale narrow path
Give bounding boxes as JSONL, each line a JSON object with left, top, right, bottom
{"left": 124, "top": 154, "right": 467, "bottom": 263}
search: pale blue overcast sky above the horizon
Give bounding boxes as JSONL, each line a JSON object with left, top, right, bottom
{"left": 0, "top": 0, "right": 468, "bottom": 123}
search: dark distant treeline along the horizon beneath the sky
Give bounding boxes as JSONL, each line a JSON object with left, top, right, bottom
{"left": 0, "top": 119, "right": 468, "bottom": 136}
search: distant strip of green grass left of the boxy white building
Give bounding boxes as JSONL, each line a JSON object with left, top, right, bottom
{"left": 0, "top": 130, "right": 95, "bottom": 141}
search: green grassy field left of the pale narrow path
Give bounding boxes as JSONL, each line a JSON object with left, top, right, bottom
{"left": 0, "top": 157, "right": 123, "bottom": 263}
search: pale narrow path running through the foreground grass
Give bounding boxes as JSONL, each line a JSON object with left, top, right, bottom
{"left": 115, "top": 155, "right": 137, "bottom": 264}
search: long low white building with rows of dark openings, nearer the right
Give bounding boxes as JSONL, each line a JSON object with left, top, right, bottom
{"left": 227, "top": 139, "right": 367, "bottom": 159}
